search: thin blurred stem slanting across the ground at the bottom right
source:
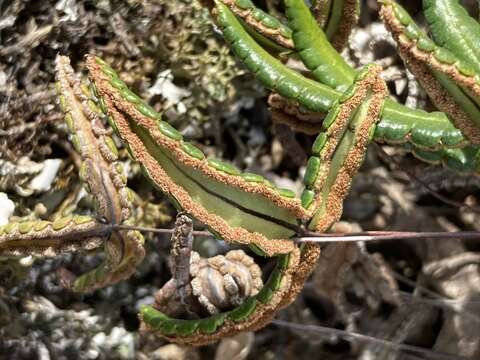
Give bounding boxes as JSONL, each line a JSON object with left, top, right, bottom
{"left": 272, "top": 319, "right": 468, "bottom": 360}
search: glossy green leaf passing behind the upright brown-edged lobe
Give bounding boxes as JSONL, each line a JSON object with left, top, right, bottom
{"left": 218, "top": 0, "right": 466, "bottom": 153}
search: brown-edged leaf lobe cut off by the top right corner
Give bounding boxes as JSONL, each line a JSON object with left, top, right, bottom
{"left": 380, "top": 0, "right": 480, "bottom": 144}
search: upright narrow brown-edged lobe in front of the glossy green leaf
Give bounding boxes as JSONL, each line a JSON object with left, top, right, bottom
{"left": 302, "top": 66, "right": 388, "bottom": 232}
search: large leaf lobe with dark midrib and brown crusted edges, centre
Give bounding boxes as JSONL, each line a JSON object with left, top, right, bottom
{"left": 87, "top": 57, "right": 306, "bottom": 256}
